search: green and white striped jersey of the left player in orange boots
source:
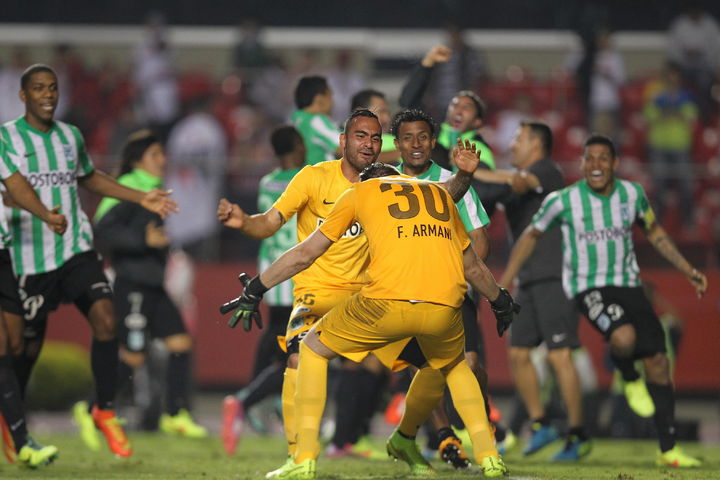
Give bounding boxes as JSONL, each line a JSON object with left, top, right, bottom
{"left": 0, "top": 118, "right": 94, "bottom": 276}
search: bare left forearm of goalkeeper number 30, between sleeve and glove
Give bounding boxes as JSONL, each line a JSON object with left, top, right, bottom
{"left": 260, "top": 229, "right": 333, "bottom": 288}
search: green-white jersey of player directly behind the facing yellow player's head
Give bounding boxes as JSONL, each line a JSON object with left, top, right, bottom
{"left": 290, "top": 110, "right": 340, "bottom": 165}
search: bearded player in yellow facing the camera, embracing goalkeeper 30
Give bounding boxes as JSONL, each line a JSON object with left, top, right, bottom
{"left": 218, "top": 110, "right": 478, "bottom": 473}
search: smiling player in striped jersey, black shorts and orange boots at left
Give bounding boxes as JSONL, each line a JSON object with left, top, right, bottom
{"left": 0, "top": 64, "right": 177, "bottom": 456}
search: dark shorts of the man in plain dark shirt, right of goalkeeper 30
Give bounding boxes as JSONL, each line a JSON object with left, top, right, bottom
{"left": 510, "top": 280, "right": 580, "bottom": 350}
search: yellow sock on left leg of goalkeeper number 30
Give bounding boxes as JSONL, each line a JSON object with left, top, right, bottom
{"left": 295, "top": 342, "right": 328, "bottom": 463}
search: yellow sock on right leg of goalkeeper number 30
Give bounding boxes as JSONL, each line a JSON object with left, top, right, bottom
{"left": 446, "top": 361, "right": 498, "bottom": 465}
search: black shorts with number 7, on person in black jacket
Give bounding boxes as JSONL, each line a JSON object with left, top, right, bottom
{"left": 114, "top": 278, "right": 187, "bottom": 352}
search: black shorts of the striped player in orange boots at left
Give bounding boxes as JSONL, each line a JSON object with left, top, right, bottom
{"left": 18, "top": 250, "right": 112, "bottom": 339}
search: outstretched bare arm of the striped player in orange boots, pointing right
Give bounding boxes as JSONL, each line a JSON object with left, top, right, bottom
{"left": 78, "top": 170, "right": 178, "bottom": 218}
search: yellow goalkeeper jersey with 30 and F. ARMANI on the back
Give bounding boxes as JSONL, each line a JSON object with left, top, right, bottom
{"left": 320, "top": 175, "right": 470, "bottom": 307}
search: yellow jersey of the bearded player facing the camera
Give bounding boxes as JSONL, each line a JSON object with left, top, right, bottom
{"left": 273, "top": 160, "right": 368, "bottom": 290}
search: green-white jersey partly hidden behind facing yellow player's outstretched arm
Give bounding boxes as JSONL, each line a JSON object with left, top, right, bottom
{"left": 258, "top": 168, "right": 300, "bottom": 307}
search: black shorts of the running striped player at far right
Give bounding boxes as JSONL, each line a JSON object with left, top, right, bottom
{"left": 575, "top": 287, "right": 666, "bottom": 359}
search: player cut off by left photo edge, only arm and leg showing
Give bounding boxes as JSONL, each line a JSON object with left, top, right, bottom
{"left": 0, "top": 139, "right": 67, "bottom": 468}
